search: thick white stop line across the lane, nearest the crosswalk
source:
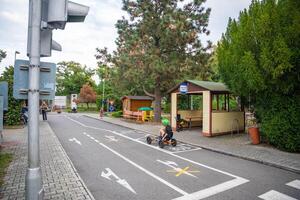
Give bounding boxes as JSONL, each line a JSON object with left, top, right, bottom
{"left": 173, "top": 178, "right": 248, "bottom": 200}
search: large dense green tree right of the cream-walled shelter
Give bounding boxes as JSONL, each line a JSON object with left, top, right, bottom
{"left": 217, "top": 0, "right": 300, "bottom": 151}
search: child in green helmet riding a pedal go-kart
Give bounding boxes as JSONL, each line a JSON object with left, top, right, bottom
{"left": 146, "top": 119, "right": 177, "bottom": 148}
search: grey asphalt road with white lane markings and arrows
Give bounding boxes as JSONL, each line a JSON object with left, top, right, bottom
{"left": 48, "top": 114, "right": 300, "bottom": 200}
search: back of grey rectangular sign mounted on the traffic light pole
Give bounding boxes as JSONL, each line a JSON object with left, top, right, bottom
{"left": 13, "top": 60, "right": 56, "bottom": 100}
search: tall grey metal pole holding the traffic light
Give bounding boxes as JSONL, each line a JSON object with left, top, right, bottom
{"left": 25, "top": 0, "right": 43, "bottom": 200}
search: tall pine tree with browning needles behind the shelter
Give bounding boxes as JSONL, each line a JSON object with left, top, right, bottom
{"left": 96, "top": 0, "right": 210, "bottom": 121}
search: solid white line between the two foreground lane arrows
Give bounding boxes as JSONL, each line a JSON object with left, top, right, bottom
{"left": 99, "top": 140, "right": 188, "bottom": 195}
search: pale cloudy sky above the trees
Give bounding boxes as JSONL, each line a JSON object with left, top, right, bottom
{"left": 0, "top": 0, "right": 251, "bottom": 81}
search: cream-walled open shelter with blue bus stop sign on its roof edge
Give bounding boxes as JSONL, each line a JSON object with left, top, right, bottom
{"left": 168, "top": 80, "right": 245, "bottom": 137}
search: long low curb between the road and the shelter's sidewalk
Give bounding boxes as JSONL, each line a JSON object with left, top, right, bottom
{"left": 83, "top": 114, "right": 300, "bottom": 174}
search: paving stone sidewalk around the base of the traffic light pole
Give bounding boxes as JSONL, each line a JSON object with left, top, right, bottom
{"left": 0, "top": 121, "right": 94, "bottom": 200}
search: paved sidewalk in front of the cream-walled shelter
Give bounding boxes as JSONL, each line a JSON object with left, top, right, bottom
{"left": 85, "top": 114, "right": 300, "bottom": 173}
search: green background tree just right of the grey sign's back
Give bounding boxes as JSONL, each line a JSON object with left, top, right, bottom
{"left": 56, "top": 61, "right": 95, "bottom": 95}
